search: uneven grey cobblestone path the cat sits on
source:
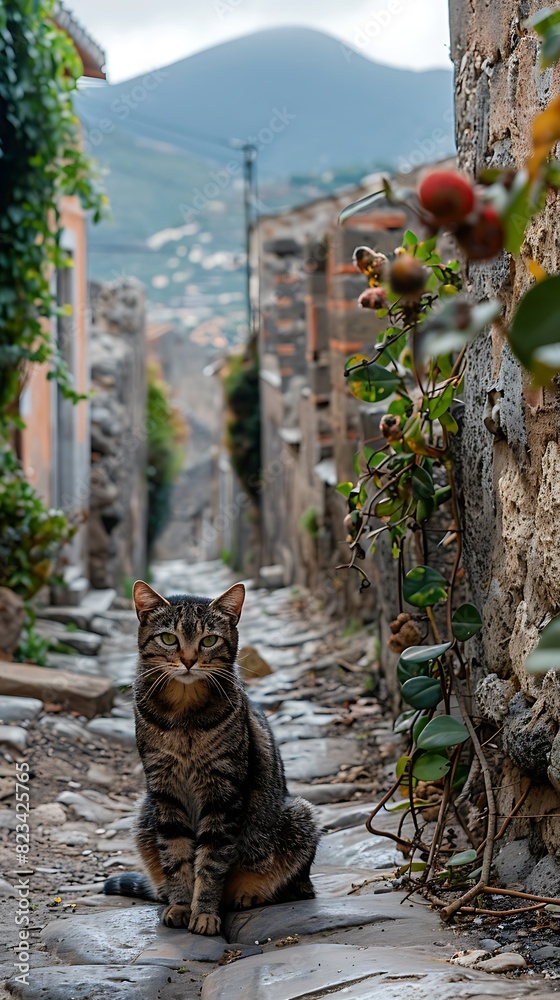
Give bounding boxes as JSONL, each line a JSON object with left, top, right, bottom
{"left": 0, "top": 561, "right": 558, "bottom": 1000}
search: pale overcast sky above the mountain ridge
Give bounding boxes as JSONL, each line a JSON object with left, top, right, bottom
{"left": 72, "top": 0, "right": 449, "bottom": 83}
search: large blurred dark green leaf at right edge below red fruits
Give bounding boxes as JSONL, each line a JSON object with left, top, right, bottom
{"left": 509, "top": 274, "right": 560, "bottom": 385}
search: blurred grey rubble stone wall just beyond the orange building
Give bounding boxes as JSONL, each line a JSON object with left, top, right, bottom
{"left": 89, "top": 278, "right": 146, "bottom": 589}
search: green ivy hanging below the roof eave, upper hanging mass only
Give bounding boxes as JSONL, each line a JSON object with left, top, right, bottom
{"left": 0, "top": 0, "right": 104, "bottom": 428}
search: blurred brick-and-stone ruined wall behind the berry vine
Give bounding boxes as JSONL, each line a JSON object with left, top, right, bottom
{"left": 254, "top": 177, "right": 442, "bottom": 616}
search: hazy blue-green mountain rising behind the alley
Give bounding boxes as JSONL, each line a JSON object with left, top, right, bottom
{"left": 77, "top": 28, "right": 453, "bottom": 332}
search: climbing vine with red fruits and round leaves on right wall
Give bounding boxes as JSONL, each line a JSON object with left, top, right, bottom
{"left": 338, "top": 10, "right": 560, "bottom": 919}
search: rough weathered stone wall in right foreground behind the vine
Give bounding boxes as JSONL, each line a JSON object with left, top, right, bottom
{"left": 450, "top": 0, "right": 560, "bottom": 854}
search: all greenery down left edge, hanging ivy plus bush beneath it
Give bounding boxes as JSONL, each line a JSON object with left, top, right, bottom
{"left": 0, "top": 0, "right": 105, "bottom": 659}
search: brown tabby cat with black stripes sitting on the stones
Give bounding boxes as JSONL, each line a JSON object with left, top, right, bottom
{"left": 105, "top": 581, "right": 319, "bottom": 934}
